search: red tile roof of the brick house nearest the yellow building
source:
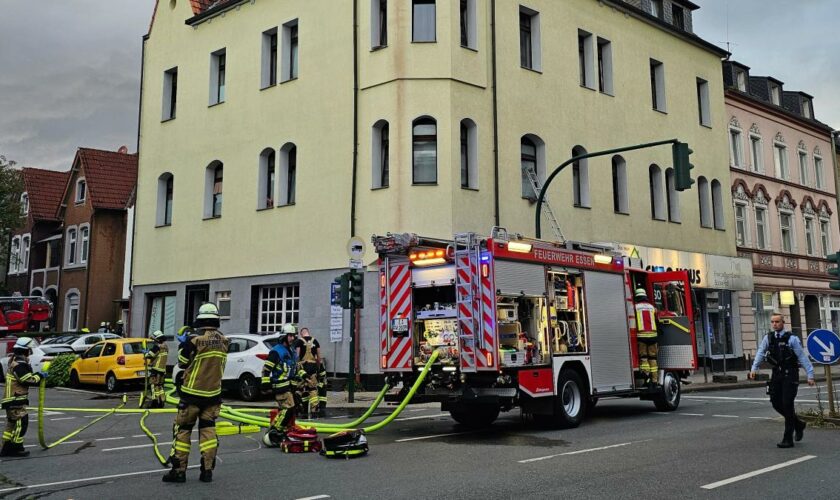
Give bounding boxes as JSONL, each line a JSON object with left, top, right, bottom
{"left": 76, "top": 148, "right": 137, "bottom": 210}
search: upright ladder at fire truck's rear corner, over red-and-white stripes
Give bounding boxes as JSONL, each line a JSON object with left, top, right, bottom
{"left": 455, "top": 233, "right": 483, "bottom": 372}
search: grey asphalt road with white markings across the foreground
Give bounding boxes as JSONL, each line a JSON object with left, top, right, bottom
{"left": 0, "top": 385, "right": 840, "bottom": 499}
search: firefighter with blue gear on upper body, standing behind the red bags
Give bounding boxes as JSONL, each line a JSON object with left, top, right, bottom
{"left": 262, "top": 324, "right": 304, "bottom": 447}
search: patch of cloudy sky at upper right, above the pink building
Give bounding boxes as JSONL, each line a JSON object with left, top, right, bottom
{"left": 694, "top": 0, "right": 840, "bottom": 129}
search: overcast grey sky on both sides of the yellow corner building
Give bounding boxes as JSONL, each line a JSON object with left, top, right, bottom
{"left": 0, "top": 0, "right": 840, "bottom": 170}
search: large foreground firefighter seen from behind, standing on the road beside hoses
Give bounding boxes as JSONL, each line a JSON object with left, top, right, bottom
{"left": 163, "top": 303, "right": 229, "bottom": 483}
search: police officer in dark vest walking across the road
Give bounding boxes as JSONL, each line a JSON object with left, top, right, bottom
{"left": 749, "top": 313, "right": 814, "bottom": 448}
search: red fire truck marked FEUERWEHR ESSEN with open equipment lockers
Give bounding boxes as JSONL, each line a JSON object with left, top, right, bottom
{"left": 373, "top": 228, "right": 698, "bottom": 427}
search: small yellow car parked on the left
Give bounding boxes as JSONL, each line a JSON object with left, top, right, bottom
{"left": 70, "top": 339, "right": 146, "bottom": 392}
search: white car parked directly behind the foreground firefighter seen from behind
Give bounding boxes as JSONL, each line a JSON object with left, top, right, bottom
{"left": 172, "top": 332, "right": 280, "bottom": 401}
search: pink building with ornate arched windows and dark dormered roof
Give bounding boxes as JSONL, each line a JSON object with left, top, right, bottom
{"left": 724, "top": 62, "right": 840, "bottom": 368}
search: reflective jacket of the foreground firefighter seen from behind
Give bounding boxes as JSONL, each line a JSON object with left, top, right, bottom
{"left": 178, "top": 328, "right": 229, "bottom": 402}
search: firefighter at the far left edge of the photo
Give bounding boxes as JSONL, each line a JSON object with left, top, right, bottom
{"left": 0, "top": 337, "right": 47, "bottom": 457}
